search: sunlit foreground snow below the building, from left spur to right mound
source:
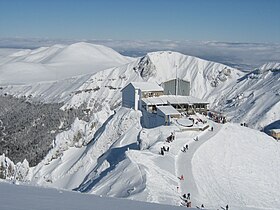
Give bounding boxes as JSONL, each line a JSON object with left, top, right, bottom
{"left": 7, "top": 108, "right": 280, "bottom": 209}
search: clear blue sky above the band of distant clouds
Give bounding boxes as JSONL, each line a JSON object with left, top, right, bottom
{"left": 0, "top": 0, "right": 280, "bottom": 43}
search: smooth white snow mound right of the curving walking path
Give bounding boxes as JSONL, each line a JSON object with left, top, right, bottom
{"left": 192, "top": 124, "right": 280, "bottom": 209}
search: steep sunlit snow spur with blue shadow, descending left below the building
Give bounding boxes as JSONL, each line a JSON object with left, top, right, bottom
{"left": 29, "top": 109, "right": 141, "bottom": 191}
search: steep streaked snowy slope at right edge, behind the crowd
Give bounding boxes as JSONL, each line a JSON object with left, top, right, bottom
{"left": 214, "top": 63, "right": 280, "bottom": 129}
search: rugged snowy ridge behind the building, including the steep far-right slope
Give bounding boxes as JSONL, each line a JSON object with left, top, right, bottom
{"left": 0, "top": 46, "right": 280, "bottom": 129}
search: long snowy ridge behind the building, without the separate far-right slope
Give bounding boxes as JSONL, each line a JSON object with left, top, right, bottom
{"left": 1, "top": 51, "right": 243, "bottom": 110}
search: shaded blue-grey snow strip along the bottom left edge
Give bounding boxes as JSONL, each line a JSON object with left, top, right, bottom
{"left": 0, "top": 181, "right": 186, "bottom": 210}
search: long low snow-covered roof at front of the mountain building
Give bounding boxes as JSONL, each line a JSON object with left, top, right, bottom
{"left": 142, "top": 95, "right": 209, "bottom": 105}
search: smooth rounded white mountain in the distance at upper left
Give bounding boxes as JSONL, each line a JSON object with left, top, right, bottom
{"left": 0, "top": 42, "right": 134, "bottom": 84}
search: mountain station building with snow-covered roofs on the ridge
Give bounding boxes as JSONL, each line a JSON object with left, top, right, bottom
{"left": 122, "top": 80, "right": 209, "bottom": 127}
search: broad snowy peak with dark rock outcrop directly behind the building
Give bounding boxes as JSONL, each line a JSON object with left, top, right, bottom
{"left": 135, "top": 51, "right": 244, "bottom": 102}
